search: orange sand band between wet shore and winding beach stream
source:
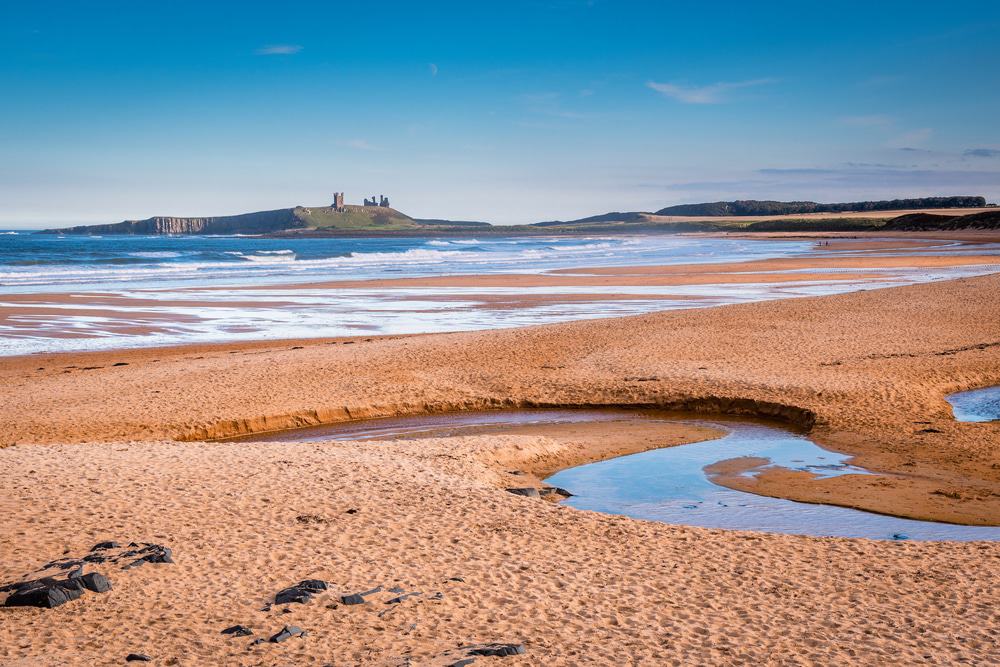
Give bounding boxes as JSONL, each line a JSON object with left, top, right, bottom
{"left": 0, "top": 276, "right": 1000, "bottom": 525}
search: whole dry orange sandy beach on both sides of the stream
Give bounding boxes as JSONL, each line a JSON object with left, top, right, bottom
{"left": 0, "top": 239, "right": 1000, "bottom": 665}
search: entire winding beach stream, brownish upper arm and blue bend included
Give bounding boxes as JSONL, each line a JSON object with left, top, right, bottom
{"left": 243, "top": 409, "right": 1000, "bottom": 541}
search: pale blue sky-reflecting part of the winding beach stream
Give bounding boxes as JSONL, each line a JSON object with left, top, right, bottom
{"left": 546, "top": 421, "right": 1000, "bottom": 541}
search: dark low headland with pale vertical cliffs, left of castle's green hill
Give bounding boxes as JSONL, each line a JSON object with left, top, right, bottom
{"left": 45, "top": 208, "right": 305, "bottom": 235}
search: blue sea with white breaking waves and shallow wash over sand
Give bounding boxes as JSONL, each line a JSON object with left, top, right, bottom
{"left": 0, "top": 230, "right": 1000, "bottom": 355}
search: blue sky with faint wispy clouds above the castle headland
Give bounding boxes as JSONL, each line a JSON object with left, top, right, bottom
{"left": 0, "top": 0, "right": 1000, "bottom": 228}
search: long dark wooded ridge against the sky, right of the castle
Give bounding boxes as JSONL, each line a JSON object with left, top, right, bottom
{"left": 656, "top": 197, "right": 986, "bottom": 217}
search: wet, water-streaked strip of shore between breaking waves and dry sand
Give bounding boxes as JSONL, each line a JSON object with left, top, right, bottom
{"left": 0, "top": 238, "right": 1000, "bottom": 357}
